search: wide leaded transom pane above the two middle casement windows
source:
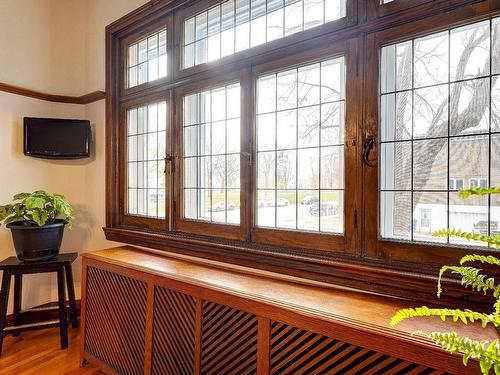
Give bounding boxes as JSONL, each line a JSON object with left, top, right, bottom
{"left": 182, "top": 0, "right": 346, "bottom": 69}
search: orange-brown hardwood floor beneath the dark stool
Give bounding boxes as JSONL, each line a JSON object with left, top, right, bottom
{"left": 0, "top": 328, "right": 103, "bottom": 375}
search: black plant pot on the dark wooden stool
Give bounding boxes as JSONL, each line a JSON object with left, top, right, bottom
{"left": 7, "top": 219, "right": 66, "bottom": 262}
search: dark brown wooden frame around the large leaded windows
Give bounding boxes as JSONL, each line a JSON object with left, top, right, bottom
{"left": 104, "top": 0, "right": 500, "bottom": 308}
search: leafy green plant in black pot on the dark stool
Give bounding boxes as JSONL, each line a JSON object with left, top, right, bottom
{"left": 0, "top": 190, "right": 73, "bottom": 262}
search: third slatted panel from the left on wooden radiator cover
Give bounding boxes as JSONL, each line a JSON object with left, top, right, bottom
{"left": 201, "top": 301, "right": 257, "bottom": 375}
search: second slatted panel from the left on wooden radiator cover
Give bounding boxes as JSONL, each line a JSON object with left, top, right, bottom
{"left": 151, "top": 287, "right": 196, "bottom": 375}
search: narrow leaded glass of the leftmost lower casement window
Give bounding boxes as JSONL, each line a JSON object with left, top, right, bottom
{"left": 126, "top": 101, "right": 167, "bottom": 218}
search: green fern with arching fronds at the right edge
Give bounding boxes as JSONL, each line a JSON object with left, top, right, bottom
{"left": 390, "top": 187, "right": 500, "bottom": 375}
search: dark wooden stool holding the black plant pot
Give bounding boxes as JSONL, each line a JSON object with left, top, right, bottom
{"left": 0, "top": 253, "right": 78, "bottom": 356}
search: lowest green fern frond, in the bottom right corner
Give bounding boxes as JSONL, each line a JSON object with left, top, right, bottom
{"left": 417, "top": 332, "right": 500, "bottom": 375}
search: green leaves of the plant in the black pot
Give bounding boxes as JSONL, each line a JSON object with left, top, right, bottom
{"left": 0, "top": 190, "right": 73, "bottom": 229}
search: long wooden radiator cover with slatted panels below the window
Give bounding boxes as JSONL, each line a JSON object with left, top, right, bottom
{"left": 81, "top": 247, "right": 488, "bottom": 375}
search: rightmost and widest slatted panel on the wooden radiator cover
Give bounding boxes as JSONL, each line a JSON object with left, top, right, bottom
{"left": 271, "top": 322, "right": 443, "bottom": 375}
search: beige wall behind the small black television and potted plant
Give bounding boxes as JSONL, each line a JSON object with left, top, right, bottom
{"left": 0, "top": 0, "right": 146, "bottom": 311}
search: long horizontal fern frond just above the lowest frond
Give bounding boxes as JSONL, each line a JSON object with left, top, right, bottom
{"left": 390, "top": 306, "right": 500, "bottom": 328}
